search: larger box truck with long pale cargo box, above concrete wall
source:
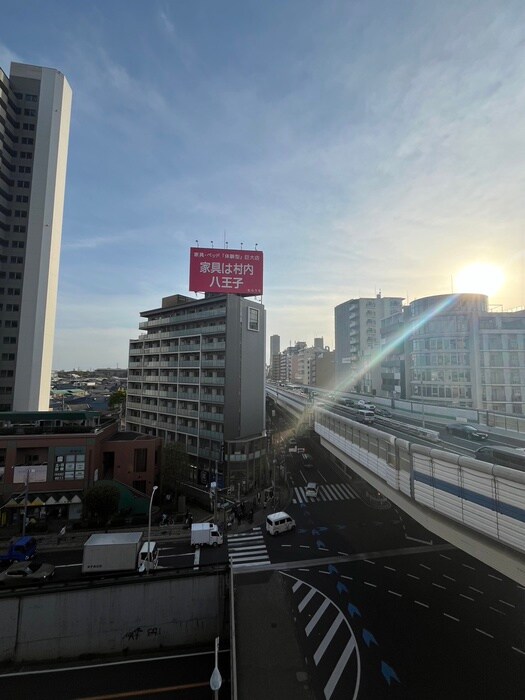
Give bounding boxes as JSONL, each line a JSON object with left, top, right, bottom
{"left": 82, "top": 532, "right": 159, "bottom": 574}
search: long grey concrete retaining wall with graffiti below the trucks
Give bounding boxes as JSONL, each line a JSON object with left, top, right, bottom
{"left": 0, "top": 567, "right": 228, "bottom": 663}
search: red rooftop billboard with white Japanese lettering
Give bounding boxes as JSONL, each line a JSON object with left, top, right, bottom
{"left": 190, "top": 248, "right": 263, "bottom": 296}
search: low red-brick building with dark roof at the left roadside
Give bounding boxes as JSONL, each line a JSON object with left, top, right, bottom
{"left": 0, "top": 411, "right": 162, "bottom": 524}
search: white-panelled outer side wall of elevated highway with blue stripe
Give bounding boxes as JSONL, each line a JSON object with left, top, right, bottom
{"left": 267, "top": 386, "right": 525, "bottom": 585}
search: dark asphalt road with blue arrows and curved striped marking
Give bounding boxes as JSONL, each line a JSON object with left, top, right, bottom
{"left": 237, "top": 440, "right": 525, "bottom": 700}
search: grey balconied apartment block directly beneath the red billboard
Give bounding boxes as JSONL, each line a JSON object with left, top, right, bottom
{"left": 126, "top": 294, "right": 267, "bottom": 489}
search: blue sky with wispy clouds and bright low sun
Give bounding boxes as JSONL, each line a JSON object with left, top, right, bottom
{"left": 0, "top": 0, "right": 525, "bottom": 369}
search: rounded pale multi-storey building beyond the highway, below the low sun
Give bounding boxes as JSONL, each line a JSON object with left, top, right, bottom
{"left": 382, "top": 294, "right": 525, "bottom": 415}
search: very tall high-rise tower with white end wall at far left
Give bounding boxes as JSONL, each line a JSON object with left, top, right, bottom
{"left": 0, "top": 63, "right": 72, "bottom": 411}
